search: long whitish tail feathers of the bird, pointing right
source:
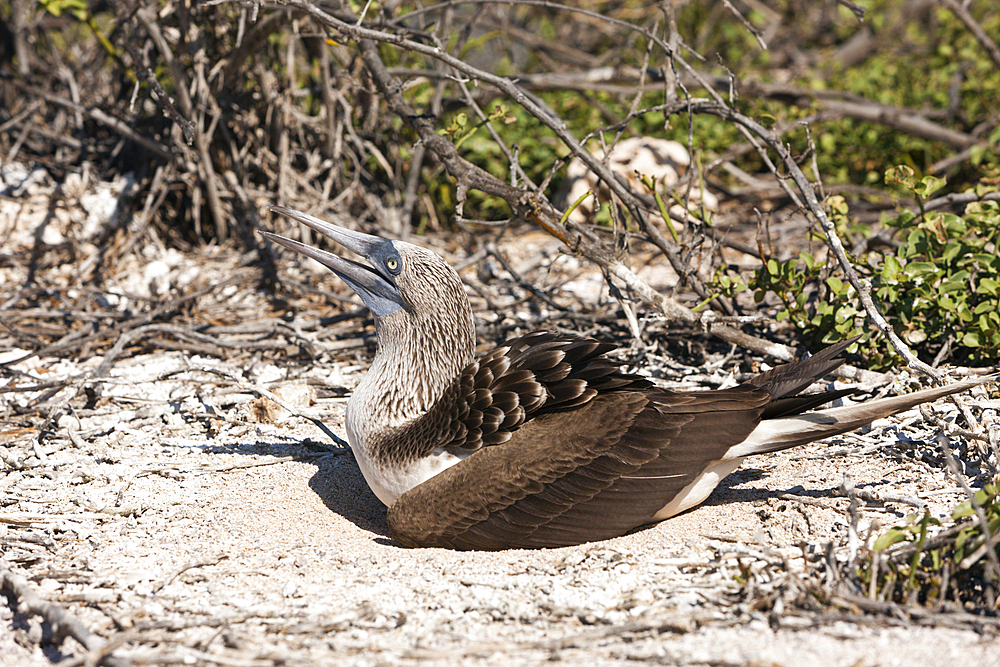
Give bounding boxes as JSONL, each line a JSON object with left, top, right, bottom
{"left": 726, "top": 373, "right": 1000, "bottom": 459}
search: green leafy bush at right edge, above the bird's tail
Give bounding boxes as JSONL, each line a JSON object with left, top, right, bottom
{"left": 744, "top": 166, "right": 1000, "bottom": 367}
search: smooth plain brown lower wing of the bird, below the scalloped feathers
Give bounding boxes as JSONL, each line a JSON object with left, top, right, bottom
{"left": 389, "top": 387, "right": 768, "bottom": 549}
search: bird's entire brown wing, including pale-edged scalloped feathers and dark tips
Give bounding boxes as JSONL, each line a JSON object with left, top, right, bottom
{"left": 388, "top": 332, "right": 868, "bottom": 549}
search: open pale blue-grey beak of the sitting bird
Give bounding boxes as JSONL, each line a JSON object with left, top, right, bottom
{"left": 259, "top": 206, "right": 403, "bottom": 317}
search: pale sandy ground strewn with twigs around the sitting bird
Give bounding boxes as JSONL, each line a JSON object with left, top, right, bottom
{"left": 0, "top": 353, "right": 1000, "bottom": 667}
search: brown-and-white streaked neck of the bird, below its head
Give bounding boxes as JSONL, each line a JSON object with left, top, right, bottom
{"left": 351, "top": 306, "right": 476, "bottom": 428}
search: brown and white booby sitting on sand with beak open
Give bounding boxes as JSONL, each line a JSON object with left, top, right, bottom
{"left": 261, "top": 206, "right": 997, "bottom": 550}
